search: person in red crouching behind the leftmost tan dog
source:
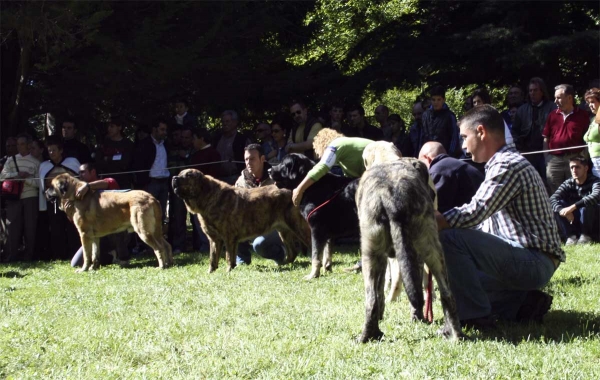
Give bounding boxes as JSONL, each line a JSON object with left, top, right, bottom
{"left": 71, "top": 162, "right": 129, "bottom": 267}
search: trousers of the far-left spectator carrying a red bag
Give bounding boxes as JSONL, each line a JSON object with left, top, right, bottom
{"left": 6, "top": 197, "right": 40, "bottom": 261}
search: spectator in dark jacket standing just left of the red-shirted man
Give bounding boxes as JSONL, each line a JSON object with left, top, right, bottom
{"left": 511, "top": 77, "right": 556, "bottom": 183}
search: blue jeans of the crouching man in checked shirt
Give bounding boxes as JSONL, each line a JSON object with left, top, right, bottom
{"left": 440, "top": 229, "right": 556, "bottom": 320}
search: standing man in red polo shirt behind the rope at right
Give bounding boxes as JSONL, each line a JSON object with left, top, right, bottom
{"left": 542, "top": 84, "right": 590, "bottom": 194}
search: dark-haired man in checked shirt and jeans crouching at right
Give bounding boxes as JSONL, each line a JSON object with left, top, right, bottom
{"left": 436, "top": 105, "right": 565, "bottom": 327}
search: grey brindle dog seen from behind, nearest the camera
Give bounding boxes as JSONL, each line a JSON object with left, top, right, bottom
{"left": 356, "top": 162, "right": 462, "bottom": 342}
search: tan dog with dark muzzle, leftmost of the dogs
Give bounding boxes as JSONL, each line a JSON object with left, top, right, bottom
{"left": 46, "top": 174, "right": 173, "bottom": 272}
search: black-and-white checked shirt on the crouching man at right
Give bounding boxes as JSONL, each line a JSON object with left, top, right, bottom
{"left": 444, "top": 145, "right": 566, "bottom": 262}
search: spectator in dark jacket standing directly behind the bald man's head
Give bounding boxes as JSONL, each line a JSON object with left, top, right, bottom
{"left": 423, "top": 86, "right": 462, "bottom": 157}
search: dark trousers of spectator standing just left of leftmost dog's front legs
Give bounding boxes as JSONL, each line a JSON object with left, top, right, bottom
{"left": 48, "top": 202, "right": 81, "bottom": 260}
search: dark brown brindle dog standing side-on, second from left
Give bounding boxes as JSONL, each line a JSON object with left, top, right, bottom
{"left": 173, "top": 169, "right": 310, "bottom": 273}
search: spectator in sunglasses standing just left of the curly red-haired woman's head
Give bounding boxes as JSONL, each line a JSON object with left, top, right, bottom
{"left": 286, "top": 101, "right": 323, "bottom": 159}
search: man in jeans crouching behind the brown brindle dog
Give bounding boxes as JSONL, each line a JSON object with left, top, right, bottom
{"left": 235, "top": 144, "right": 286, "bottom": 265}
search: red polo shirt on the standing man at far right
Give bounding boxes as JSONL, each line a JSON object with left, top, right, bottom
{"left": 542, "top": 107, "right": 590, "bottom": 155}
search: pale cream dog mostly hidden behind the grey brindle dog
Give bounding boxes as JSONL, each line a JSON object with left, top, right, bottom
{"left": 363, "top": 141, "right": 437, "bottom": 302}
